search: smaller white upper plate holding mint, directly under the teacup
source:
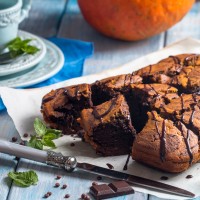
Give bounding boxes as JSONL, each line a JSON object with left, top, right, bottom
{"left": 0, "top": 31, "right": 46, "bottom": 76}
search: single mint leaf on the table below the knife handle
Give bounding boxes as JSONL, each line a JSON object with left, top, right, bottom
{"left": 8, "top": 170, "right": 38, "bottom": 187}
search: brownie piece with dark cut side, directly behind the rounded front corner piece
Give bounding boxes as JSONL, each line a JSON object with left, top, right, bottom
{"left": 126, "top": 83, "right": 178, "bottom": 132}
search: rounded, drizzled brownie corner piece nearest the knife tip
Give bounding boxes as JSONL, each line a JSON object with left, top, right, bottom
{"left": 132, "top": 111, "right": 199, "bottom": 172}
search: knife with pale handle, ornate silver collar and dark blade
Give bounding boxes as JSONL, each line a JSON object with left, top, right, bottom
{"left": 0, "top": 140, "right": 195, "bottom": 198}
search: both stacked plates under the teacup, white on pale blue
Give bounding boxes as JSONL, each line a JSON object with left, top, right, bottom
{"left": 0, "top": 31, "right": 64, "bottom": 87}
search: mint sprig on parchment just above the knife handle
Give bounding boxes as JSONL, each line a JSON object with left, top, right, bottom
{"left": 27, "top": 118, "right": 62, "bottom": 150}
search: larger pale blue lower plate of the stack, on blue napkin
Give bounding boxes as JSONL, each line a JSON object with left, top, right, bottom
{"left": 0, "top": 31, "right": 64, "bottom": 87}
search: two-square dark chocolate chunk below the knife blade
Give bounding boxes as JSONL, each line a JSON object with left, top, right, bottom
{"left": 90, "top": 181, "right": 134, "bottom": 200}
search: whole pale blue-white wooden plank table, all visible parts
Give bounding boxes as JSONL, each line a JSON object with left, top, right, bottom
{"left": 0, "top": 0, "right": 200, "bottom": 200}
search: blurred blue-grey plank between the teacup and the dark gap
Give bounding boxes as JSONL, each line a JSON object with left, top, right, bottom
{"left": 19, "top": 0, "right": 67, "bottom": 37}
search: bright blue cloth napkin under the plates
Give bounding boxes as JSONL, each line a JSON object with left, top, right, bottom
{"left": 0, "top": 38, "right": 93, "bottom": 110}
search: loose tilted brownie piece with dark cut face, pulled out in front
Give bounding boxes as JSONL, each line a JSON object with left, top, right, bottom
{"left": 78, "top": 95, "right": 135, "bottom": 156}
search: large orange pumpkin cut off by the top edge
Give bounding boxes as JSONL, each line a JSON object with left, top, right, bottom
{"left": 78, "top": 0, "right": 195, "bottom": 41}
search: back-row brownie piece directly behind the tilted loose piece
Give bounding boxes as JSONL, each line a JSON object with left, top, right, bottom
{"left": 91, "top": 74, "right": 142, "bottom": 105}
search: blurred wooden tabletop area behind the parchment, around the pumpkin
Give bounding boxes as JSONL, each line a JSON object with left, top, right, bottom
{"left": 20, "top": 0, "right": 200, "bottom": 75}
